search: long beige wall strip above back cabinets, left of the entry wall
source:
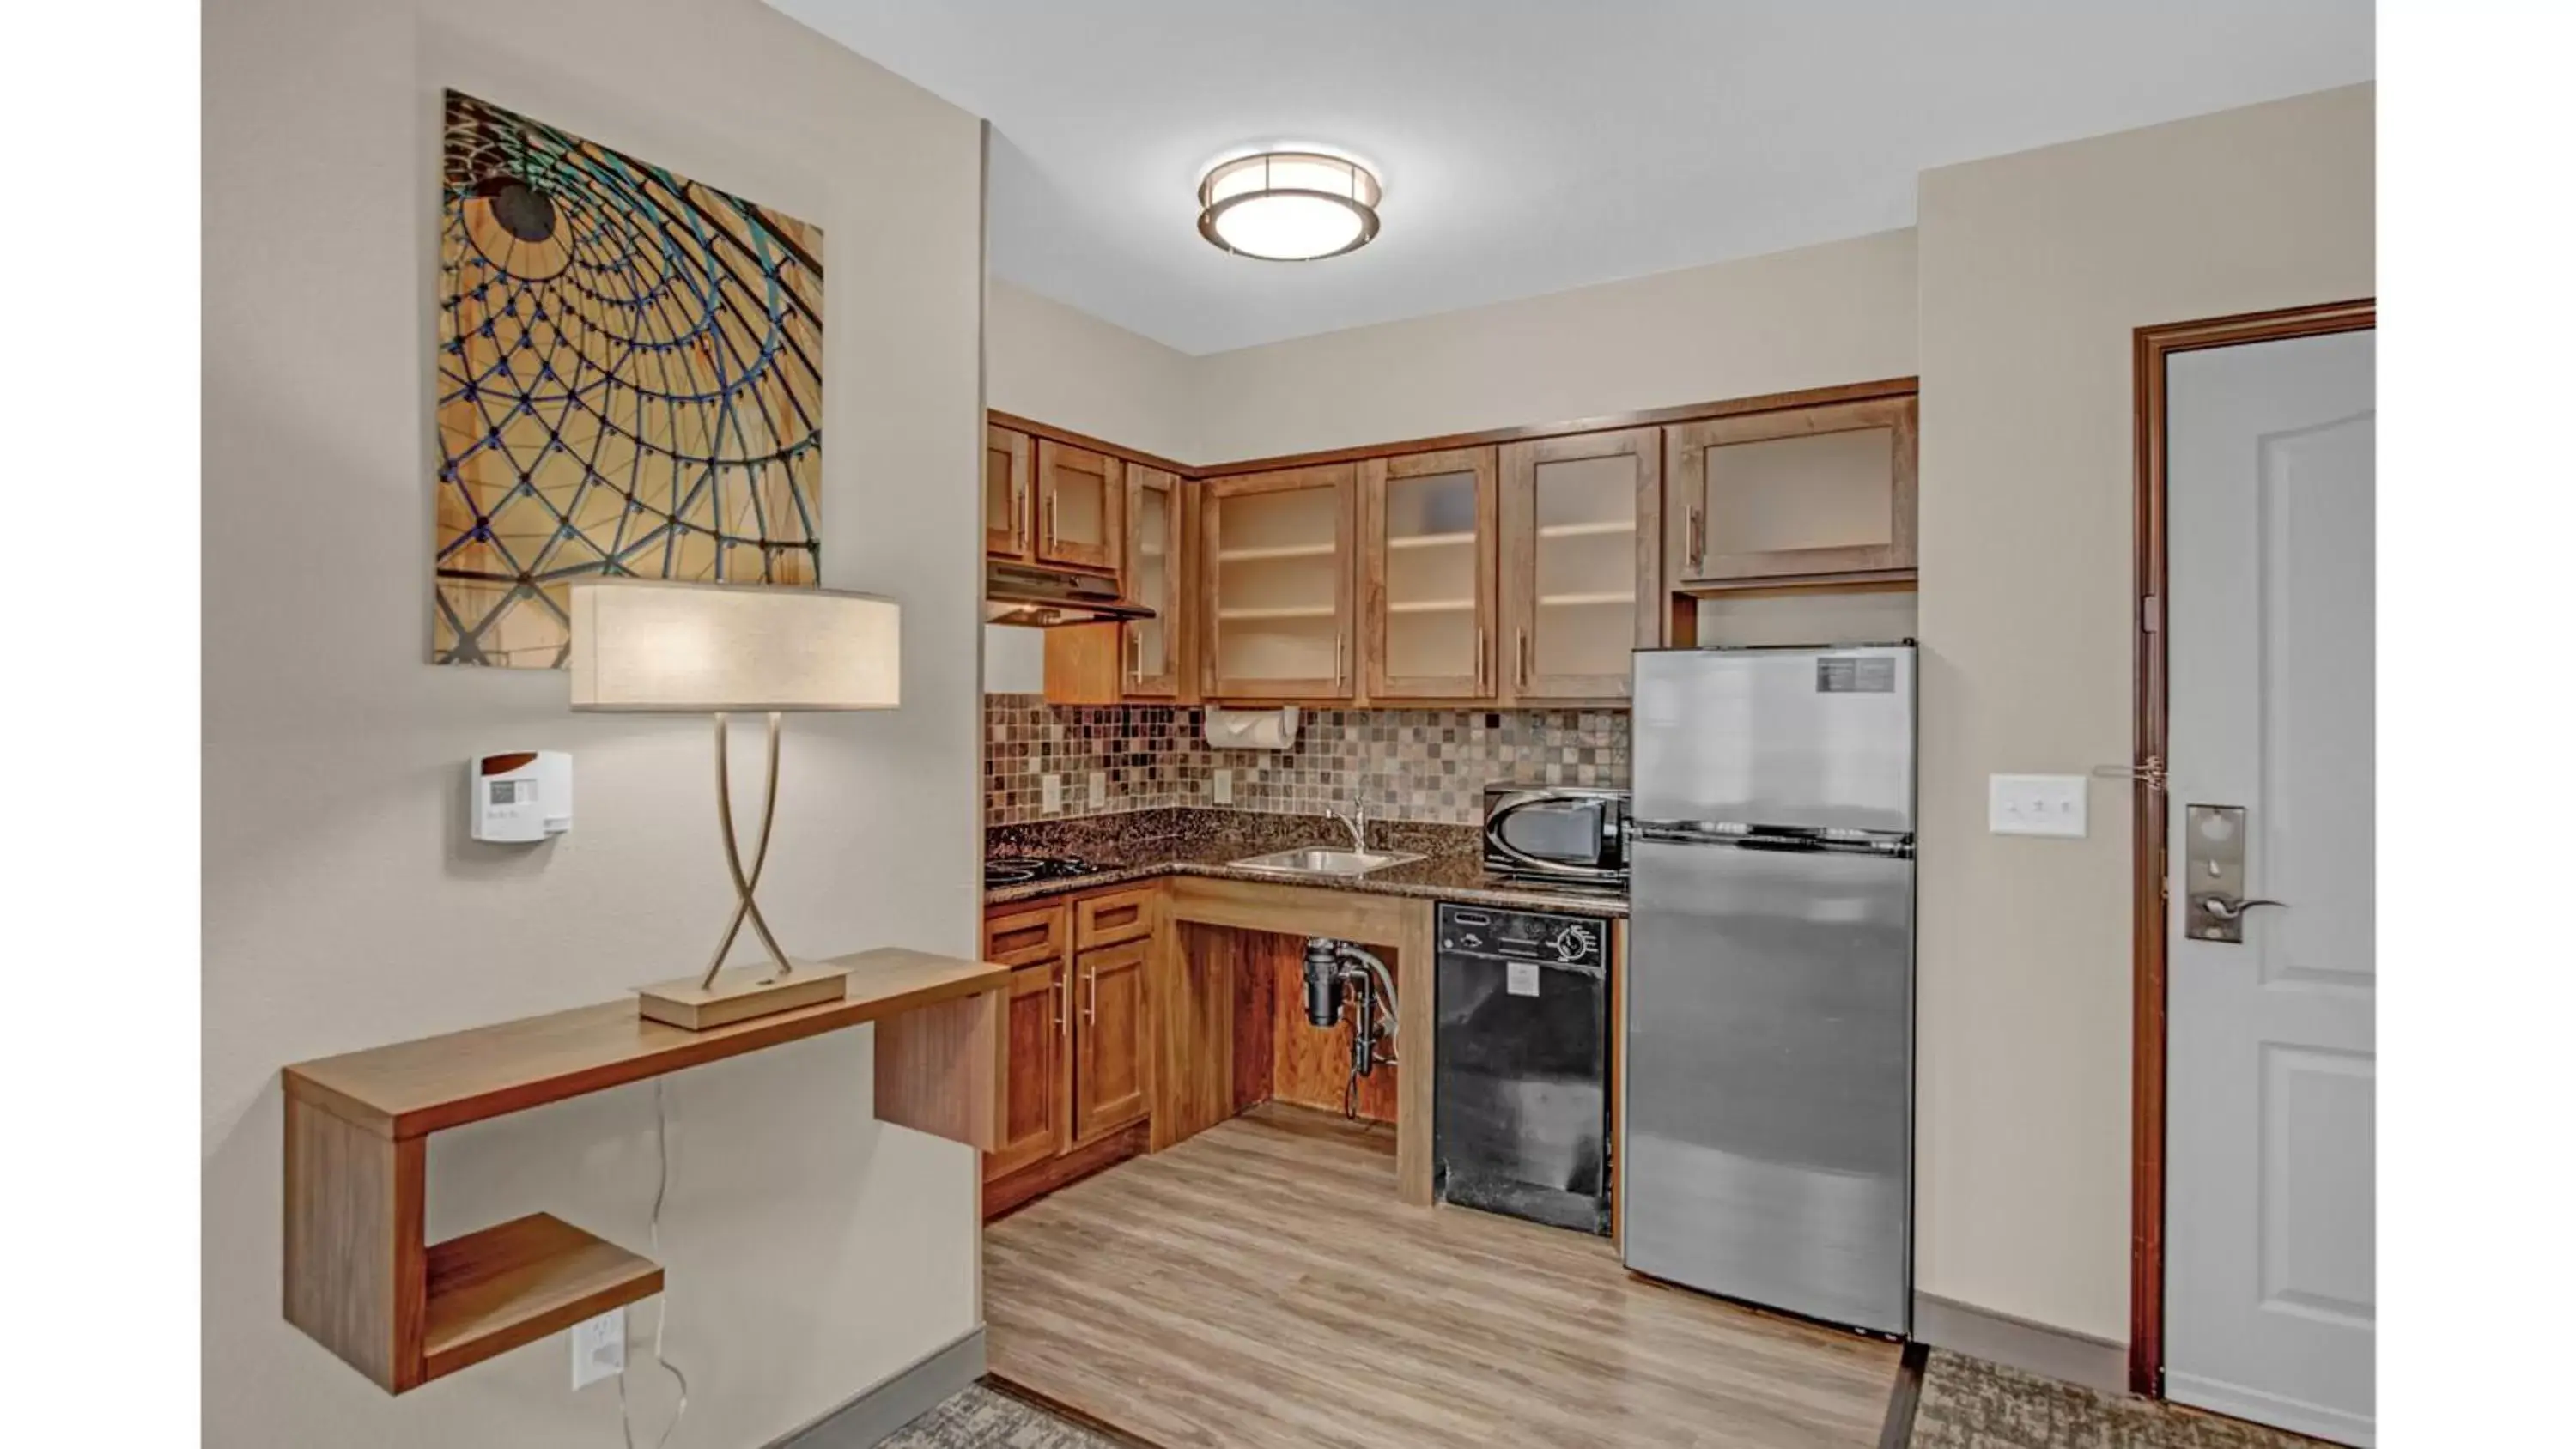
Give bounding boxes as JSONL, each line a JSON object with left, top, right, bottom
{"left": 1190, "top": 232, "right": 1914, "bottom": 464}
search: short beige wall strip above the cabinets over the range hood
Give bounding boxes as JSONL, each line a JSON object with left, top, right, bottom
{"left": 984, "top": 278, "right": 1198, "bottom": 464}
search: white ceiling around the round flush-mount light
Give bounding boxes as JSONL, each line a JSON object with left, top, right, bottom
{"left": 770, "top": 0, "right": 2372, "bottom": 353}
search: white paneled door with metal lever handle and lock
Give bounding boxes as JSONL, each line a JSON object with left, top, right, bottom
{"left": 2164, "top": 332, "right": 2378, "bottom": 1446}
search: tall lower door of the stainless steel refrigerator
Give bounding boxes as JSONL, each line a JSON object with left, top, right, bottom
{"left": 1623, "top": 841, "right": 1914, "bottom": 1333}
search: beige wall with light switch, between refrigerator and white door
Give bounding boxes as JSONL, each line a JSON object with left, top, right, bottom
{"left": 1917, "top": 85, "right": 2372, "bottom": 1341}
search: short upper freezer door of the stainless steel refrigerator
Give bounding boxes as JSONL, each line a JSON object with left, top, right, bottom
{"left": 1631, "top": 646, "right": 1914, "bottom": 831}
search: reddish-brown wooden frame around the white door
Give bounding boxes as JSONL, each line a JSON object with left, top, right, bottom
{"left": 2128, "top": 296, "right": 2380, "bottom": 1397}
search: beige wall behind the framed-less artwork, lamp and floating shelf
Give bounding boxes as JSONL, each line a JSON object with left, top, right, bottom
{"left": 201, "top": 0, "right": 981, "bottom": 1449}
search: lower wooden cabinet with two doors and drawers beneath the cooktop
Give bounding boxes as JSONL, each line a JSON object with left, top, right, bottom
{"left": 984, "top": 888, "right": 1162, "bottom": 1217}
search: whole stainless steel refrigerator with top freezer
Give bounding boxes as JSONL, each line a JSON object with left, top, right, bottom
{"left": 1620, "top": 646, "right": 1914, "bottom": 1333}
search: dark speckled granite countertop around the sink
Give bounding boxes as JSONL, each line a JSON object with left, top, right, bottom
{"left": 984, "top": 808, "right": 1628, "bottom": 916}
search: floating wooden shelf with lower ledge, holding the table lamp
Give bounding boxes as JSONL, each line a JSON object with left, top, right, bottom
{"left": 281, "top": 949, "right": 1010, "bottom": 1392}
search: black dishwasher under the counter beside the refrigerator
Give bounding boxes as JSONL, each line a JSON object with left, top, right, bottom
{"left": 1432, "top": 903, "right": 1610, "bottom": 1233}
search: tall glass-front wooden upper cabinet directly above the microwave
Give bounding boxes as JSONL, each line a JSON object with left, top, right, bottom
{"left": 1494, "top": 427, "right": 1664, "bottom": 703}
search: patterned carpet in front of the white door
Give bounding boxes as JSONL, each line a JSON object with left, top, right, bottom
{"left": 1909, "top": 1349, "right": 2329, "bottom": 1449}
